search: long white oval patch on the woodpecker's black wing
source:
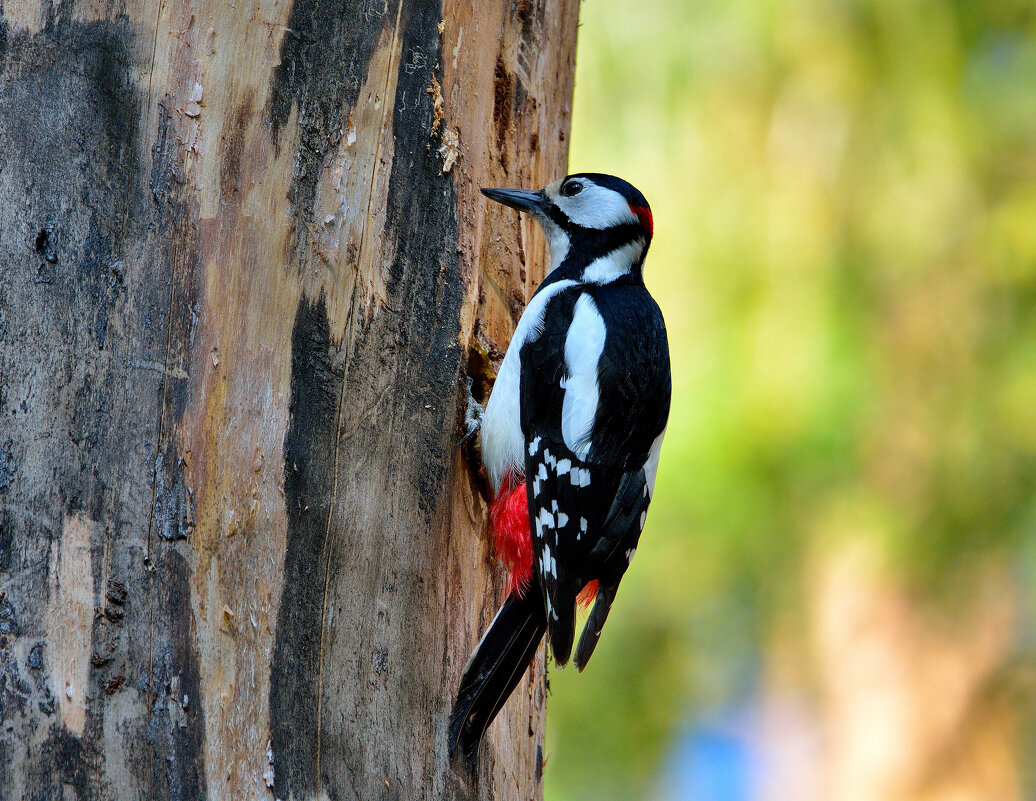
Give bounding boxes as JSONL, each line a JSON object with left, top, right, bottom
{"left": 563, "top": 294, "right": 606, "bottom": 460}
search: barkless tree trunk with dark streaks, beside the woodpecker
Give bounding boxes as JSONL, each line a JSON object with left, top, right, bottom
{"left": 0, "top": 0, "right": 578, "bottom": 801}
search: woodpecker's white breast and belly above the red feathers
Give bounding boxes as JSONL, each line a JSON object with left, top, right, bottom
{"left": 482, "top": 280, "right": 576, "bottom": 493}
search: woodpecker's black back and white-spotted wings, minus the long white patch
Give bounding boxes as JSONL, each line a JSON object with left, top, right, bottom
{"left": 521, "top": 283, "right": 670, "bottom": 669}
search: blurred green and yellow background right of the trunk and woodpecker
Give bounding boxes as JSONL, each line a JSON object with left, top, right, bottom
{"left": 545, "top": 0, "right": 1036, "bottom": 801}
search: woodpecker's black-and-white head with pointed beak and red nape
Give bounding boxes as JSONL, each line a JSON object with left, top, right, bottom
{"left": 482, "top": 172, "right": 653, "bottom": 280}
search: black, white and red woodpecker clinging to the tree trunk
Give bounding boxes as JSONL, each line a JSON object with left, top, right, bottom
{"left": 450, "top": 173, "right": 671, "bottom": 765}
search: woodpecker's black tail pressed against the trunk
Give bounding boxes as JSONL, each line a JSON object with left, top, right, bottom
{"left": 450, "top": 587, "right": 547, "bottom": 769}
